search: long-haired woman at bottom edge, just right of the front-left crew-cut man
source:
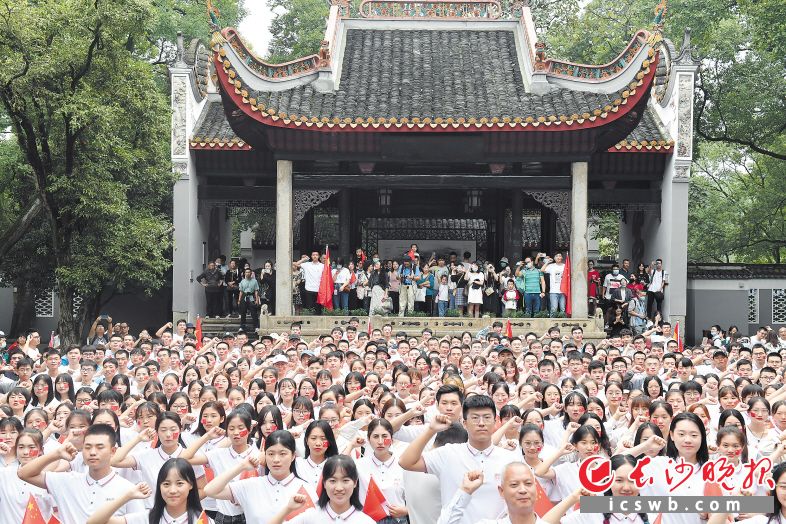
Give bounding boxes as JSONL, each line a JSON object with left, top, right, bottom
{"left": 86, "top": 458, "right": 202, "bottom": 524}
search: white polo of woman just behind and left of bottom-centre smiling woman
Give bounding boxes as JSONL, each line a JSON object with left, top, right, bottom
{"left": 229, "top": 473, "right": 318, "bottom": 524}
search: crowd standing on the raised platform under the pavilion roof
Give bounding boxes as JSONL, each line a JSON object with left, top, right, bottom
{"left": 205, "top": 244, "right": 669, "bottom": 334}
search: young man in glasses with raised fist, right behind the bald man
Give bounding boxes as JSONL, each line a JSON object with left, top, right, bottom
{"left": 399, "top": 395, "right": 521, "bottom": 524}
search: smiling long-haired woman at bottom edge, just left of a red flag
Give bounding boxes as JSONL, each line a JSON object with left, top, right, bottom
{"left": 268, "top": 455, "right": 374, "bottom": 524}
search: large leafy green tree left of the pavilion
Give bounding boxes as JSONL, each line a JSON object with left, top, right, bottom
{"left": 0, "top": 0, "right": 174, "bottom": 343}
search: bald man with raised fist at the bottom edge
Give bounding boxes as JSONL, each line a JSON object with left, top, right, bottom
{"left": 437, "top": 462, "right": 546, "bottom": 524}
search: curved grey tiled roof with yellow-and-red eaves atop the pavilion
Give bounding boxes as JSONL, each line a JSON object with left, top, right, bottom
{"left": 214, "top": 28, "right": 657, "bottom": 131}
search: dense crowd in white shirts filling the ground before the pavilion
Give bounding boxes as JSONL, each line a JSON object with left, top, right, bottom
{"left": 0, "top": 316, "right": 786, "bottom": 524}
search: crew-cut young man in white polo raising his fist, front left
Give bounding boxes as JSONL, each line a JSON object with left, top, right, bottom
{"left": 19, "top": 424, "right": 144, "bottom": 524}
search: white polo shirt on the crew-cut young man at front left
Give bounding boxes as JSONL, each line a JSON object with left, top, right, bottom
{"left": 44, "top": 471, "right": 145, "bottom": 524}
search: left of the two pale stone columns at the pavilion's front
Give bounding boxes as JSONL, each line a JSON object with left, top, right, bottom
{"left": 276, "top": 160, "right": 294, "bottom": 316}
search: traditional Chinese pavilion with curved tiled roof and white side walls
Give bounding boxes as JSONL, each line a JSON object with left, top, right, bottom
{"left": 171, "top": 0, "right": 697, "bottom": 334}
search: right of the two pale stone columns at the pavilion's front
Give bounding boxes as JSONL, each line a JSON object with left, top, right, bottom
{"left": 570, "top": 162, "right": 588, "bottom": 318}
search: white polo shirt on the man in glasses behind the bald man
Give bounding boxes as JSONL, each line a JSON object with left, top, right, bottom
{"left": 423, "top": 443, "right": 521, "bottom": 524}
